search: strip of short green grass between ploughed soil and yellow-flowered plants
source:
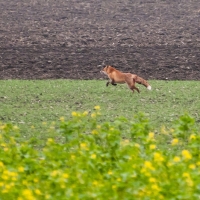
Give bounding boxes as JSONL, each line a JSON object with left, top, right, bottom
{"left": 0, "top": 80, "right": 200, "bottom": 143}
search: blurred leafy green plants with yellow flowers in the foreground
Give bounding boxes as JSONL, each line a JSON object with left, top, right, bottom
{"left": 0, "top": 106, "right": 200, "bottom": 200}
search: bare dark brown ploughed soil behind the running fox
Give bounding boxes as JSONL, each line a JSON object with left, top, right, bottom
{"left": 0, "top": 0, "right": 200, "bottom": 80}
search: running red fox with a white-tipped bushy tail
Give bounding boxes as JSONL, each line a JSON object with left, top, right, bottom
{"left": 100, "top": 65, "right": 151, "bottom": 93}
